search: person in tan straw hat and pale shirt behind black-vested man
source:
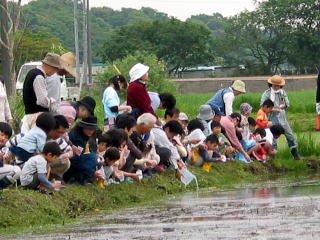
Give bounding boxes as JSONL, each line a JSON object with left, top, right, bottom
{"left": 46, "top": 52, "right": 76, "bottom": 104}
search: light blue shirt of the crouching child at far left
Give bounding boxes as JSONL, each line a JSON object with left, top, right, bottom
{"left": 17, "top": 127, "right": 47, "bottom": 153}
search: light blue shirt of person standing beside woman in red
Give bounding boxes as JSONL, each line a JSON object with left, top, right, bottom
{"left": 102, "top": 87, "right": 120, "bottom": 118}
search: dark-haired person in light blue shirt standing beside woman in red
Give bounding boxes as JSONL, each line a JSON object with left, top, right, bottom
{"left": 102, "top": 75, "right": 131, "bottom": 132}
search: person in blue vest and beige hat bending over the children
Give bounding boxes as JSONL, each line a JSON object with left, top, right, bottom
{"left": 207, "top": 80, "right": 246, "bottom": 116}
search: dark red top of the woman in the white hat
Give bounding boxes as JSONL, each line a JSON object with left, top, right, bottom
{"left": 127, "top": 80, "right": 156, "bottom": 116}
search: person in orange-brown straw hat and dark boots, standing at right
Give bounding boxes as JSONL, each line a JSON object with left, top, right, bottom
{"left": 260, "top": 75, "right": 301, "bottom": 160}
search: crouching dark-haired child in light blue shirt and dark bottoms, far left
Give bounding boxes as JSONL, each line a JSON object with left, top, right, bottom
{"left": 10, "top": 112, "right": 56, "bottom": 165}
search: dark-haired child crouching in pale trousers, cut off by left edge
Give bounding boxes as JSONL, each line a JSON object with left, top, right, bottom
{"left": 0, "top": 122, "right": 21, "bottom": 190}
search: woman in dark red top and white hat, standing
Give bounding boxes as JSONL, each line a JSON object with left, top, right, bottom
{"left": 127, "top": 63, "right": 156, "bottom": 118}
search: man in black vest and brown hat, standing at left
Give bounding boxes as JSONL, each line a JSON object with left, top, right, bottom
{"left": 21, "top": 53, "right": 62, "bottom": 133}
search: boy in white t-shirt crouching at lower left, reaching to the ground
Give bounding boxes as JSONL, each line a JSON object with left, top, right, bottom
{"left": 20, "top": 141, "right": 61, "bottom": 190}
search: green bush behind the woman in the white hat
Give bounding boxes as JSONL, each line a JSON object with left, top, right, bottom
{"left": 98, "top": 51, "right": 177, "bottom": 94}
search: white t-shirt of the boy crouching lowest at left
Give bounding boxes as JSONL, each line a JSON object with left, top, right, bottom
{"left": 20, "top": 155, "right": 47, "bottom": 186}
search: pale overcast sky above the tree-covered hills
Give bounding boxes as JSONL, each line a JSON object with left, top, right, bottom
{"left": 22, "top": 0, "right": 254, "bottom": 20}
